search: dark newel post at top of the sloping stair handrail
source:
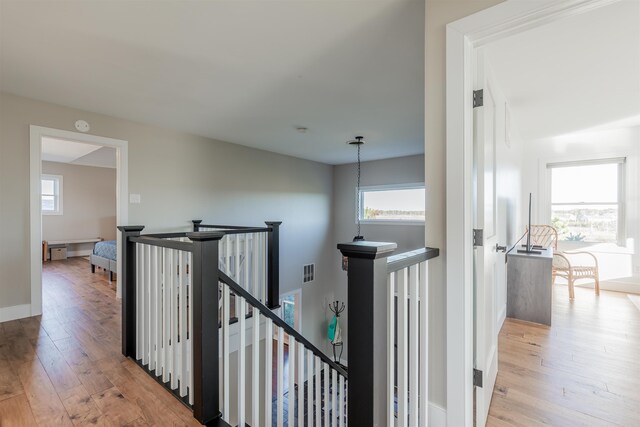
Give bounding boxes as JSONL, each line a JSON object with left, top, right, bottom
{"left": 187, "top": 231, "right": 224, "bottom": 425}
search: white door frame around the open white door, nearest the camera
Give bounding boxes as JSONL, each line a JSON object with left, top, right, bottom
{"left": 446, "top": 0, "right": 618, "bottom": 427}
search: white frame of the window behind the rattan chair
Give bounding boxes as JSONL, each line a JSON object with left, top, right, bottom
{"left": 546, "top": 156, "right": 627, "bottom": 246}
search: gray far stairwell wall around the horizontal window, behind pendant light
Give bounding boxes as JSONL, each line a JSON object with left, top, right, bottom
{"left": 329, "top": 154, "right": 429, "bottom": 360}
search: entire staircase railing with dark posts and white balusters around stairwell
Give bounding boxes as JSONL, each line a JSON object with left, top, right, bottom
{"left": 119, "top": 221, "right": 437, "bottom": 427}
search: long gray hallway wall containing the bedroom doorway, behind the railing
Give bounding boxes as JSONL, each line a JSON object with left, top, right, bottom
{"left": 0, "top": 93, "right": 334, "bottom": 346}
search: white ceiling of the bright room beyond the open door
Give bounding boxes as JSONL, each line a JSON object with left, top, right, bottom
{"left": 487, "top": 0, "right": 640, "bottom": 140}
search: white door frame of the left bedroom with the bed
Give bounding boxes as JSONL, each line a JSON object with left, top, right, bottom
{"left": 29, "top": 125, "right": 129, "bottom": 316}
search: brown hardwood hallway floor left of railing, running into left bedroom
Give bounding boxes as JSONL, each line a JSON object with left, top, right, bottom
{"left": 0, "top": 258, "right": 199, "bottom": 427}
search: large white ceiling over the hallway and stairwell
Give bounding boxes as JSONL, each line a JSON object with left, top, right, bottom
{"left": 0, "top": 0, "right": 424, "bottom": 164}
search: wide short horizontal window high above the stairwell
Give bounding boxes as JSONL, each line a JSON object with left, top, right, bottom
{"left": 358, "top": 183, "right": 425, "bottom": 225}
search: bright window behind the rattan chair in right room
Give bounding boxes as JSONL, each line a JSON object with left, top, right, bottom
{"left": 547, "top": 158, "right": 625, "bottom": 243}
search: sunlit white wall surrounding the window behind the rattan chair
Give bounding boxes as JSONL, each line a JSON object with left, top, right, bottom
{"left": 523, "top": 126, "right": 640, "bottom": 293}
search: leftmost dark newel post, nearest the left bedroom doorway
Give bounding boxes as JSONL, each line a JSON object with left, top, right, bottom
{"left": 118, "top": 225, "right": 144, "bottom": 359}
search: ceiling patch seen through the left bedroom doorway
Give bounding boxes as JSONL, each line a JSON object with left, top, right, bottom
{"left": 41, "top": 136, "right": 116, "bottom": 169}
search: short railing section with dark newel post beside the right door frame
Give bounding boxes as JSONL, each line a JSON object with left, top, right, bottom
{"left": 338, "top": 241, "right": 439, "bottom": 427}
